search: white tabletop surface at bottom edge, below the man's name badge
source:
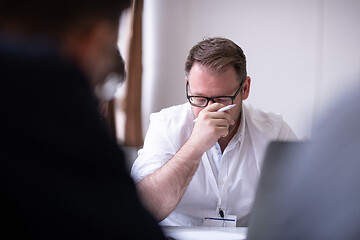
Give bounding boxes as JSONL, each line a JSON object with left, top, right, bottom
{"left": 162, "top": 227, "right": 247, "bottom": 240}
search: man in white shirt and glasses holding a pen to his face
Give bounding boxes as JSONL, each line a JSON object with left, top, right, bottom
{"left": 131, "top": 38, "right": 296, "bottom": 226}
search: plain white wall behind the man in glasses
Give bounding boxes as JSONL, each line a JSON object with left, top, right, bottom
{"left": 143, "top": 0, "right": 360, "bottom": 138}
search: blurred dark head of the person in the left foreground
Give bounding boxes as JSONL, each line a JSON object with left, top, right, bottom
{"left": 0, "top": 0, "right": 130, "bottom": 95}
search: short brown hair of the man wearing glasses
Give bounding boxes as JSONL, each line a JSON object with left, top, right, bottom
{"left": 185, "top": 37, "right": 247, "bottom": 82}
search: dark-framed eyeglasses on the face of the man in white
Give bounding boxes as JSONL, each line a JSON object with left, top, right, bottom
{"left": 186, "top": 81, "right": 244, "bottom": 107}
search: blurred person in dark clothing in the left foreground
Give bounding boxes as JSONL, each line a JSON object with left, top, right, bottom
{"left": 0, "top": 0, "right": 163, "bottom": 239}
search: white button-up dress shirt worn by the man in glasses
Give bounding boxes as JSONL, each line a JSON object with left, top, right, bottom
{"left": 131, "top": 103, "right": 296, "bottom": 226}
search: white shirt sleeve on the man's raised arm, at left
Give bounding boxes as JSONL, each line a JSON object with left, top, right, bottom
{"left": 131, "top": 103, "right": 193, "bottom": 183}
